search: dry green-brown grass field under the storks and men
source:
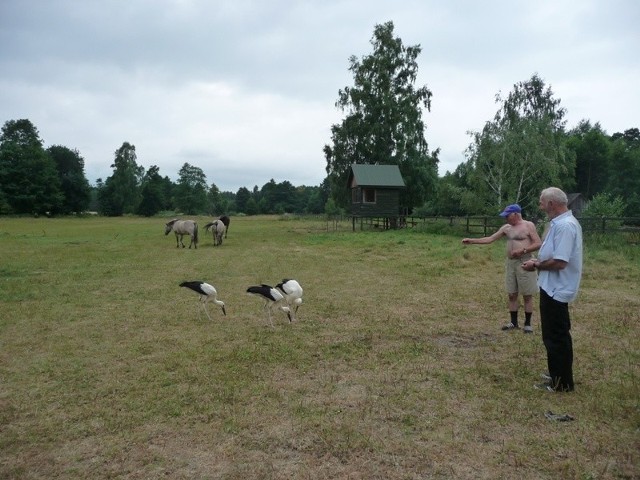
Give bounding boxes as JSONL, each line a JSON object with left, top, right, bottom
{"left": 0, "top": 217, "right": 640, "bottom": 480}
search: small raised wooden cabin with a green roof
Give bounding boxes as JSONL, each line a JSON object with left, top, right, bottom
{"left": 347, "top": 164, "right": 406, "bottom": 228}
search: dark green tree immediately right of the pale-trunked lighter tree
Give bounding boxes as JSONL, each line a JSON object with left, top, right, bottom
{"left": 567, "top": 124, "right": 611, "bottom": 199}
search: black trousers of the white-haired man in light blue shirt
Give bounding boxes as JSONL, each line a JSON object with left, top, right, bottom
{"left": 540, "top": 289, "right": 573, "bottom": 391}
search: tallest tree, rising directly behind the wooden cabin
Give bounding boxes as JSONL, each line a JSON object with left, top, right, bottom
{"left": 324, "top": 22, "right": 438, "bottom": 208}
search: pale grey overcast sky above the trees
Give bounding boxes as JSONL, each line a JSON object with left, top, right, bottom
{"left": 0, "top": 0, "right": 640, "bottom": 192}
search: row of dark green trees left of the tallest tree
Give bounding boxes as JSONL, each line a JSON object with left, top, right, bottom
{"left": 0, "top": 119, "right": 328, "bottom": 216}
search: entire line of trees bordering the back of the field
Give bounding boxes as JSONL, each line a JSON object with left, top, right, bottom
{"left": 0, "top": 22, "right": 640, "bottom": 216}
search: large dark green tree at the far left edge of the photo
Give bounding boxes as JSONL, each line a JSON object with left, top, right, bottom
{"left": 0, "top": 119, "right": 64, "bottom": 214}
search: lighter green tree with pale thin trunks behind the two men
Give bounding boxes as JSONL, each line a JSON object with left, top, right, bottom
{"left": 467, "top": 74, "right": 575, "bottom": 212}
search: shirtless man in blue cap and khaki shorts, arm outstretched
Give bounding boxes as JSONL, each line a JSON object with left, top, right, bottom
{"left": 462, "top": 203, "right": 542, "bottom": 333}
